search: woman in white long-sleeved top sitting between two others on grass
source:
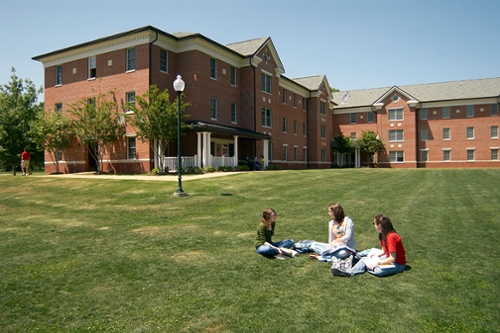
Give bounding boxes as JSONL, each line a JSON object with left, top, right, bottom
{"left": 309, "top": 203, "right": 356, "bottom": 261}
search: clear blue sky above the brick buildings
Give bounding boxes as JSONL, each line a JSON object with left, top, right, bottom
{"left": 0, "top": 0, "right": 500, "bottom": 100}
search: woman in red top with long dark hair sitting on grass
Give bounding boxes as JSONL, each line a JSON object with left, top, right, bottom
{"left": 332, "top": 214, "right": 406, "bottom": 277}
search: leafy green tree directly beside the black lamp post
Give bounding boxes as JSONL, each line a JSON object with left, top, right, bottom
{"left": 127, "top": 85, "right": 189, "bottom": 173}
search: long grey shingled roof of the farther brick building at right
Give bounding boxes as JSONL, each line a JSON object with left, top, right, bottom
{"left": 333, "top": 78, "right": 500, "bottom": 108}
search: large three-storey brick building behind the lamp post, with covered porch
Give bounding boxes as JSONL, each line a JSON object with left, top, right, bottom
{"left": 33, "top": 26, "right": 333, "bottom": 173}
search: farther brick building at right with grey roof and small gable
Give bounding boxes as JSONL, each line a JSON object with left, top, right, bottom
{"left": 332, "top": 78, "right": 500, "bottom": 168}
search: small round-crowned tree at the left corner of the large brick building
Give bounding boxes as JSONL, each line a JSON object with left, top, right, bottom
{"left": 31, "top": 111, "right": 73, "bottom": 173}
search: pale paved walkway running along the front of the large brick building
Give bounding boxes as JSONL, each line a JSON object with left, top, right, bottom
{"left": 34, "top": 171, "right": 247, "bottom": 182}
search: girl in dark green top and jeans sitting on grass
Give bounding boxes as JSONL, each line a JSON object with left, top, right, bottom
{"left": 255, "top": 208, "right": 295, "bottom": 258}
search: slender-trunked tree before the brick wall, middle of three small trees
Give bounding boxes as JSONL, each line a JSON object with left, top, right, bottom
{"left": 69, "top": 91, "right": 125, "bottom": 173}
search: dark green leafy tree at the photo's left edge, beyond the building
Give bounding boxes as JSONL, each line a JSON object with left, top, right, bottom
{"left": 0, "top": 68, "right": 43, "bottom": 175}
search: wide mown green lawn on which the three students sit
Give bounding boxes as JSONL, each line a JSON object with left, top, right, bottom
{"left": 0, "top": 169, "right": 500, "bottom": 332}
